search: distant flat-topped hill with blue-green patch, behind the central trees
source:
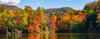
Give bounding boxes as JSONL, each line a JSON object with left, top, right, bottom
{"left": 44, "top": 7, "right": 73, "bottom": 13}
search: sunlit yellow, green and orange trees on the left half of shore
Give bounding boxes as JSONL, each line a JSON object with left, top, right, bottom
{"left": 0, "top": 6, "right": 56, "bottom": 33}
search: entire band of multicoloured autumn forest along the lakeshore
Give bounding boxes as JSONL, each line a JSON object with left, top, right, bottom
{"left": 0, "top": 0, "right": 100, "bottom": 33}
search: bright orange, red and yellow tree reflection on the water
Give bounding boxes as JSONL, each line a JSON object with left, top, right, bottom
{"left": 27, "top": 34, "right": 56, "bottom": 39}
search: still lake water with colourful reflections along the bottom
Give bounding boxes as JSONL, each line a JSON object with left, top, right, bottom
{"left": 0, "top": 33, "right": 100, "bottom": 39}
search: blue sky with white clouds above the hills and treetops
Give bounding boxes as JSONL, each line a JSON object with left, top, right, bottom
{"left": 0, "top": 0, "right": 95, "bottom": 10}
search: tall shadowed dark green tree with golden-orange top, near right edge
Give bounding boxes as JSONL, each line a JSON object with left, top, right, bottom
{"left": 83, "top": 2, "right": 97, "bottom": 31}
